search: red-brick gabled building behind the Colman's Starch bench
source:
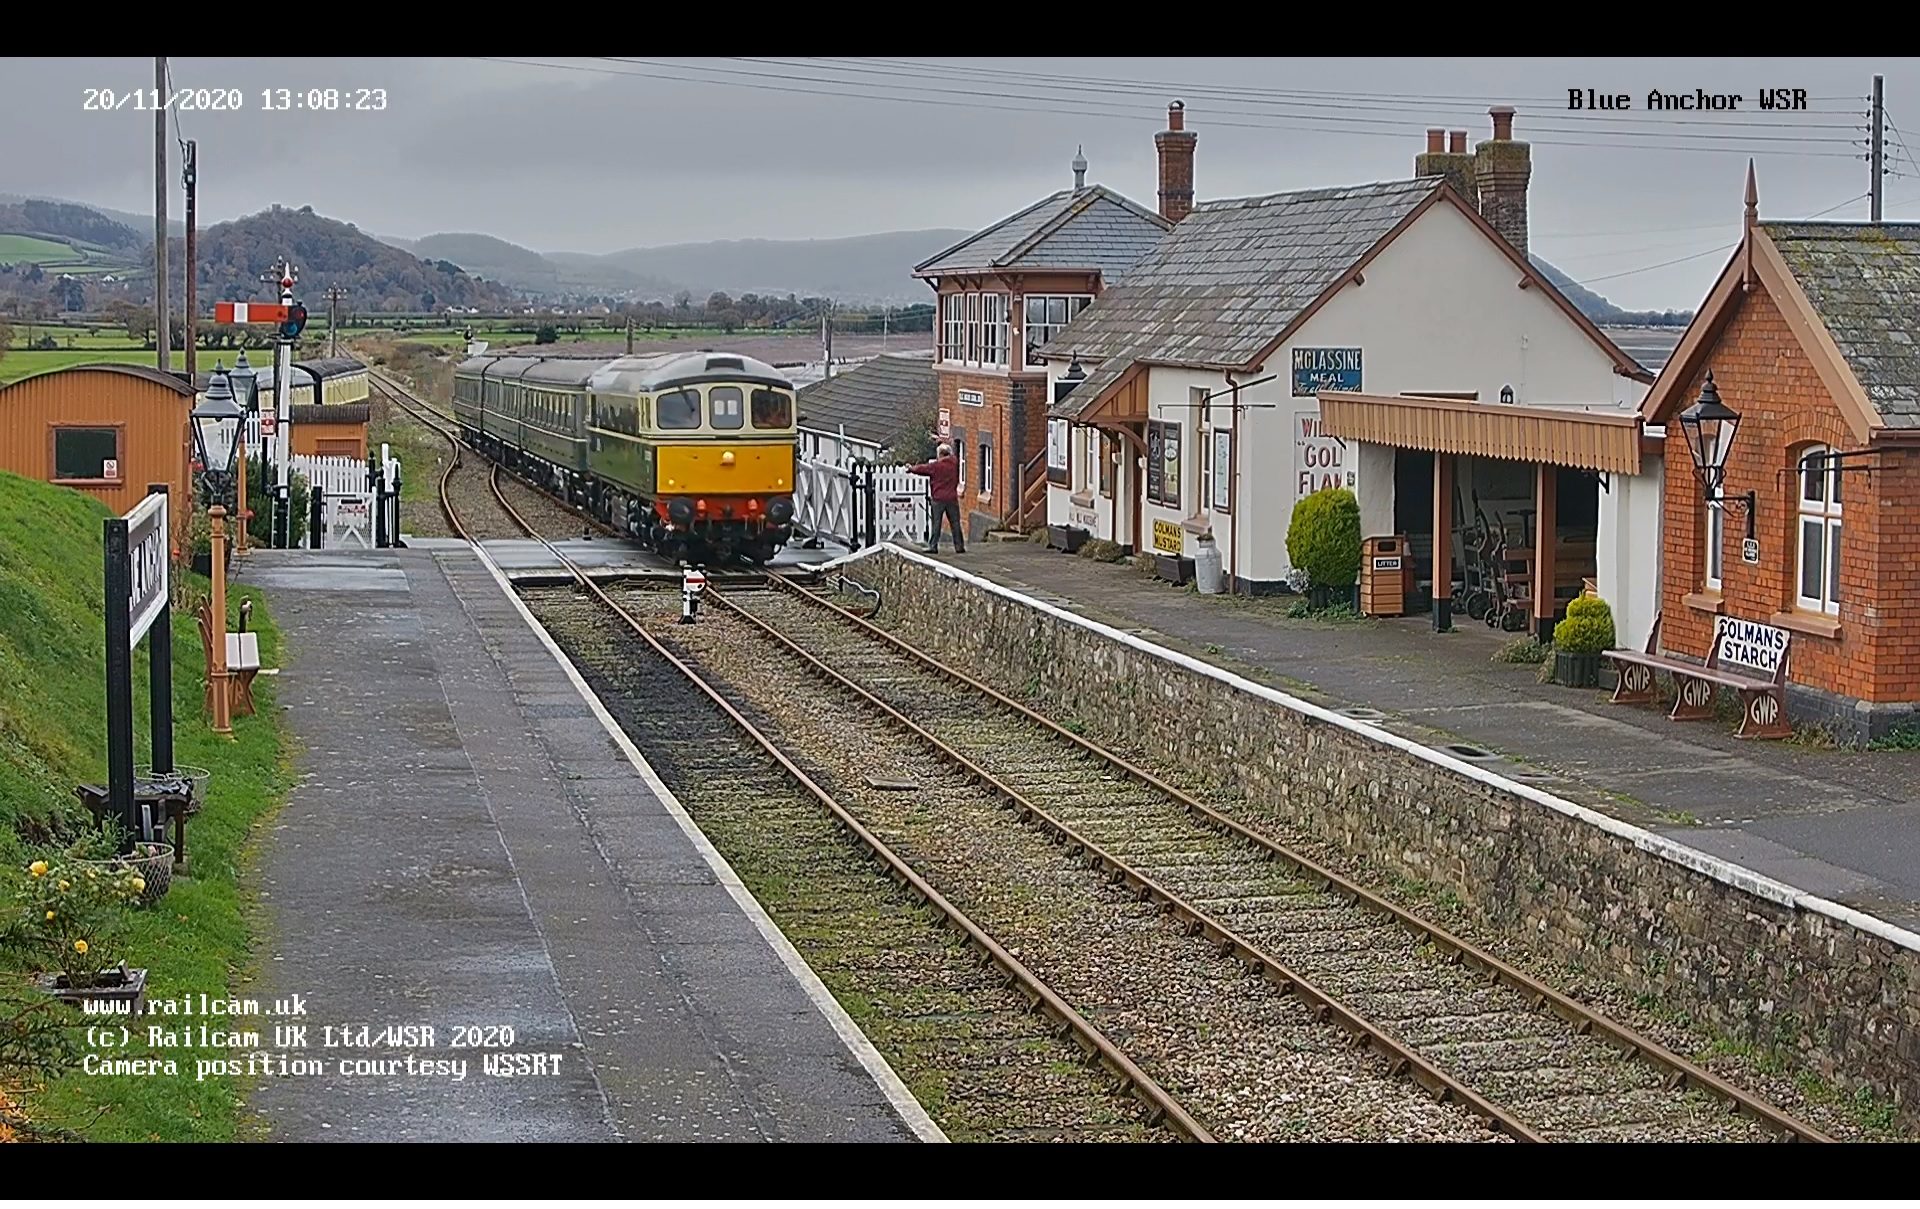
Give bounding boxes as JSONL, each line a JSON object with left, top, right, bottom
{"left": 1622, "top": 171, "right": 1920, "bottom": 739}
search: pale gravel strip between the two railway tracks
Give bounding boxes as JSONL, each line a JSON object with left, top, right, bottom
{"left": 636, "top": 597, "right": 1500, "bottom": 1142}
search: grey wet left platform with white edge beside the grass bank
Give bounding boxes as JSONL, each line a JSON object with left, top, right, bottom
{"left": 236, "top": 541, "right": 939, "bottom": 1142}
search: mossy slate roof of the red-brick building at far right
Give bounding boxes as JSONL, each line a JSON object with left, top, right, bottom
{"left": 1761, "top": 223, "right": 1920, "bottom": 428}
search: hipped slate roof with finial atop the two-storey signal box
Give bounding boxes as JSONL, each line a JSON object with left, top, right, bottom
{"left": 914, "top": 184, "right": 1173, "bottom": 282}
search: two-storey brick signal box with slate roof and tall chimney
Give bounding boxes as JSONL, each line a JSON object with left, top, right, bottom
{"left": 914, "top": 135, "right": 1167, "bottom": 537}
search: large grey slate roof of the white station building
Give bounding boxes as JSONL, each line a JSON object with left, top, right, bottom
{"left": 1046, "top": 177, "right": 1442, "bottom": 416}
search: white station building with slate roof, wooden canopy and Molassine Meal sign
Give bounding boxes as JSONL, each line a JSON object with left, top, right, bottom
{"left": 1041, "top": 107, "right": 1659, "bottom": 644}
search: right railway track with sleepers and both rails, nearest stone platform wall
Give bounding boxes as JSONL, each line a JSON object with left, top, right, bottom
{"left": 675, "top": 578, "right": 1828, "bottom": 1140}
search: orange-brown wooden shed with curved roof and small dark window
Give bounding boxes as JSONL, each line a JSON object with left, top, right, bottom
{"left": 0, "top": 365, "right": 194, "bottom": 549}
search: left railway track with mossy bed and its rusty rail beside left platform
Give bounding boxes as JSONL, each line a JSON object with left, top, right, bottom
{"left": 476, "top": 487, "right": 1213, "bottom": 1142}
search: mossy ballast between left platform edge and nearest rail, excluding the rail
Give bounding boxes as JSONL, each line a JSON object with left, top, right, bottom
{"left": 524, "top": 587, "right": 1177, "bottom": 1142}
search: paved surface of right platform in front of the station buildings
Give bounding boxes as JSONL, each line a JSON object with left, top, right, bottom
{"left": 943, "top": 541, "right": 1920, "bottom": 929}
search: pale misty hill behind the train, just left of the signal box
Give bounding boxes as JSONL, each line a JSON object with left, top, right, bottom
{"left": 583, "top": 230, "right": 972, "bottom": 301}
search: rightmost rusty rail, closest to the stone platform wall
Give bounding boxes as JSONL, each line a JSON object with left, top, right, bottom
{"left": 756, "top": 574, "right": 1832, "bottom": 1142}
